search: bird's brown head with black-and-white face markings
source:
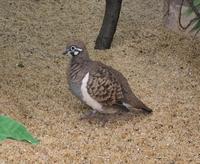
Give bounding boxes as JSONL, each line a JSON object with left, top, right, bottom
{"left": 63, "top": 41, "right": 87, "bottom": 57}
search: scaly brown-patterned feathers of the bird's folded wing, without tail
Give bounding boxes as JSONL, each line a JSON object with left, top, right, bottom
{"left": 87, "top": 62, "right": 124, "bottom": 106}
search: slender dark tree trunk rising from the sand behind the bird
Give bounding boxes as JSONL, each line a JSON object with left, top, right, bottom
{"left": 95, "top": 0, "right": 122, "bottom": 49}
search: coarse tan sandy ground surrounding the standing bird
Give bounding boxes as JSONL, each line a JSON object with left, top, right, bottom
{"left": 0, "top": 0, "right": 200, "bottom": 164}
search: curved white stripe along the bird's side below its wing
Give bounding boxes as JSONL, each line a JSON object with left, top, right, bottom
{"left": 81, "top": 72, "right": 103, "bottom": 112}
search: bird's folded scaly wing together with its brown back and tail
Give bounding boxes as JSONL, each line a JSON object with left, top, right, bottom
{"left": 87, "top": 62, "right": 152, "bottom": 112}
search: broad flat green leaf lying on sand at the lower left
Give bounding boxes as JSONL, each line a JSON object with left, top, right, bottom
{"left": 0, "top": 115, "right": 39, "bottom": 144}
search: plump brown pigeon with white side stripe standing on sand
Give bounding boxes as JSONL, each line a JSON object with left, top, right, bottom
{"left": 63, "top": 40, "right": 152, "bottom": 118}
